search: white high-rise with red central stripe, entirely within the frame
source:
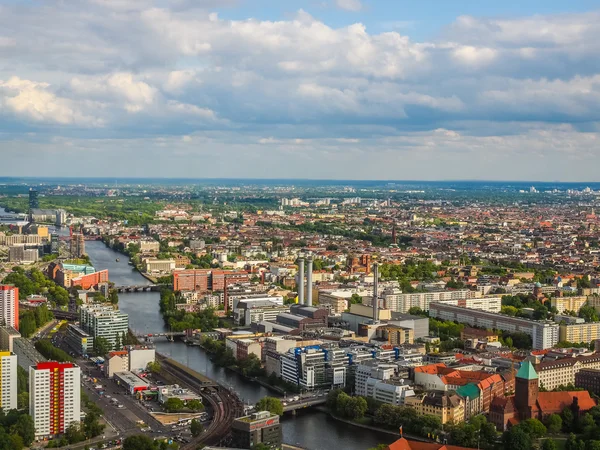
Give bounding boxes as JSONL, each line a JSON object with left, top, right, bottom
{"left": 29, "top": 361, "right": 81, "bottom": 439}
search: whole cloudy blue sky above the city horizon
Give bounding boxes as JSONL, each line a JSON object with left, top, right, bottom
{"left": 0, "top": 0, "right": 600, "bottom": 181}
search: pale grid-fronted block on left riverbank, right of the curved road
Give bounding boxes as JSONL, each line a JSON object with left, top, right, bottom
{"left": 79, "top": 305, "right": 129, "bottom": 348}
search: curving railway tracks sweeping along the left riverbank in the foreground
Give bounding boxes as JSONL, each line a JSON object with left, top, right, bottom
{"left": 161, "top": 359, "right": 241, "bottom": 450}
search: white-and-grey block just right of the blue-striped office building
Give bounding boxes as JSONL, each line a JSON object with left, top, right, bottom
{"left": 355, "top": 360, "right": 415, "bottom": 406}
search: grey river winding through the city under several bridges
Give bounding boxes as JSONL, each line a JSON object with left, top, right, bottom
{"left": 85, "top": 241, "right": 394, "bottom": 450}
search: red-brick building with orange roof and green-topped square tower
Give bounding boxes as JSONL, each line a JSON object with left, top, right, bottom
{"left": 489, "top": 361, "right": 596, "bottom": 431}
